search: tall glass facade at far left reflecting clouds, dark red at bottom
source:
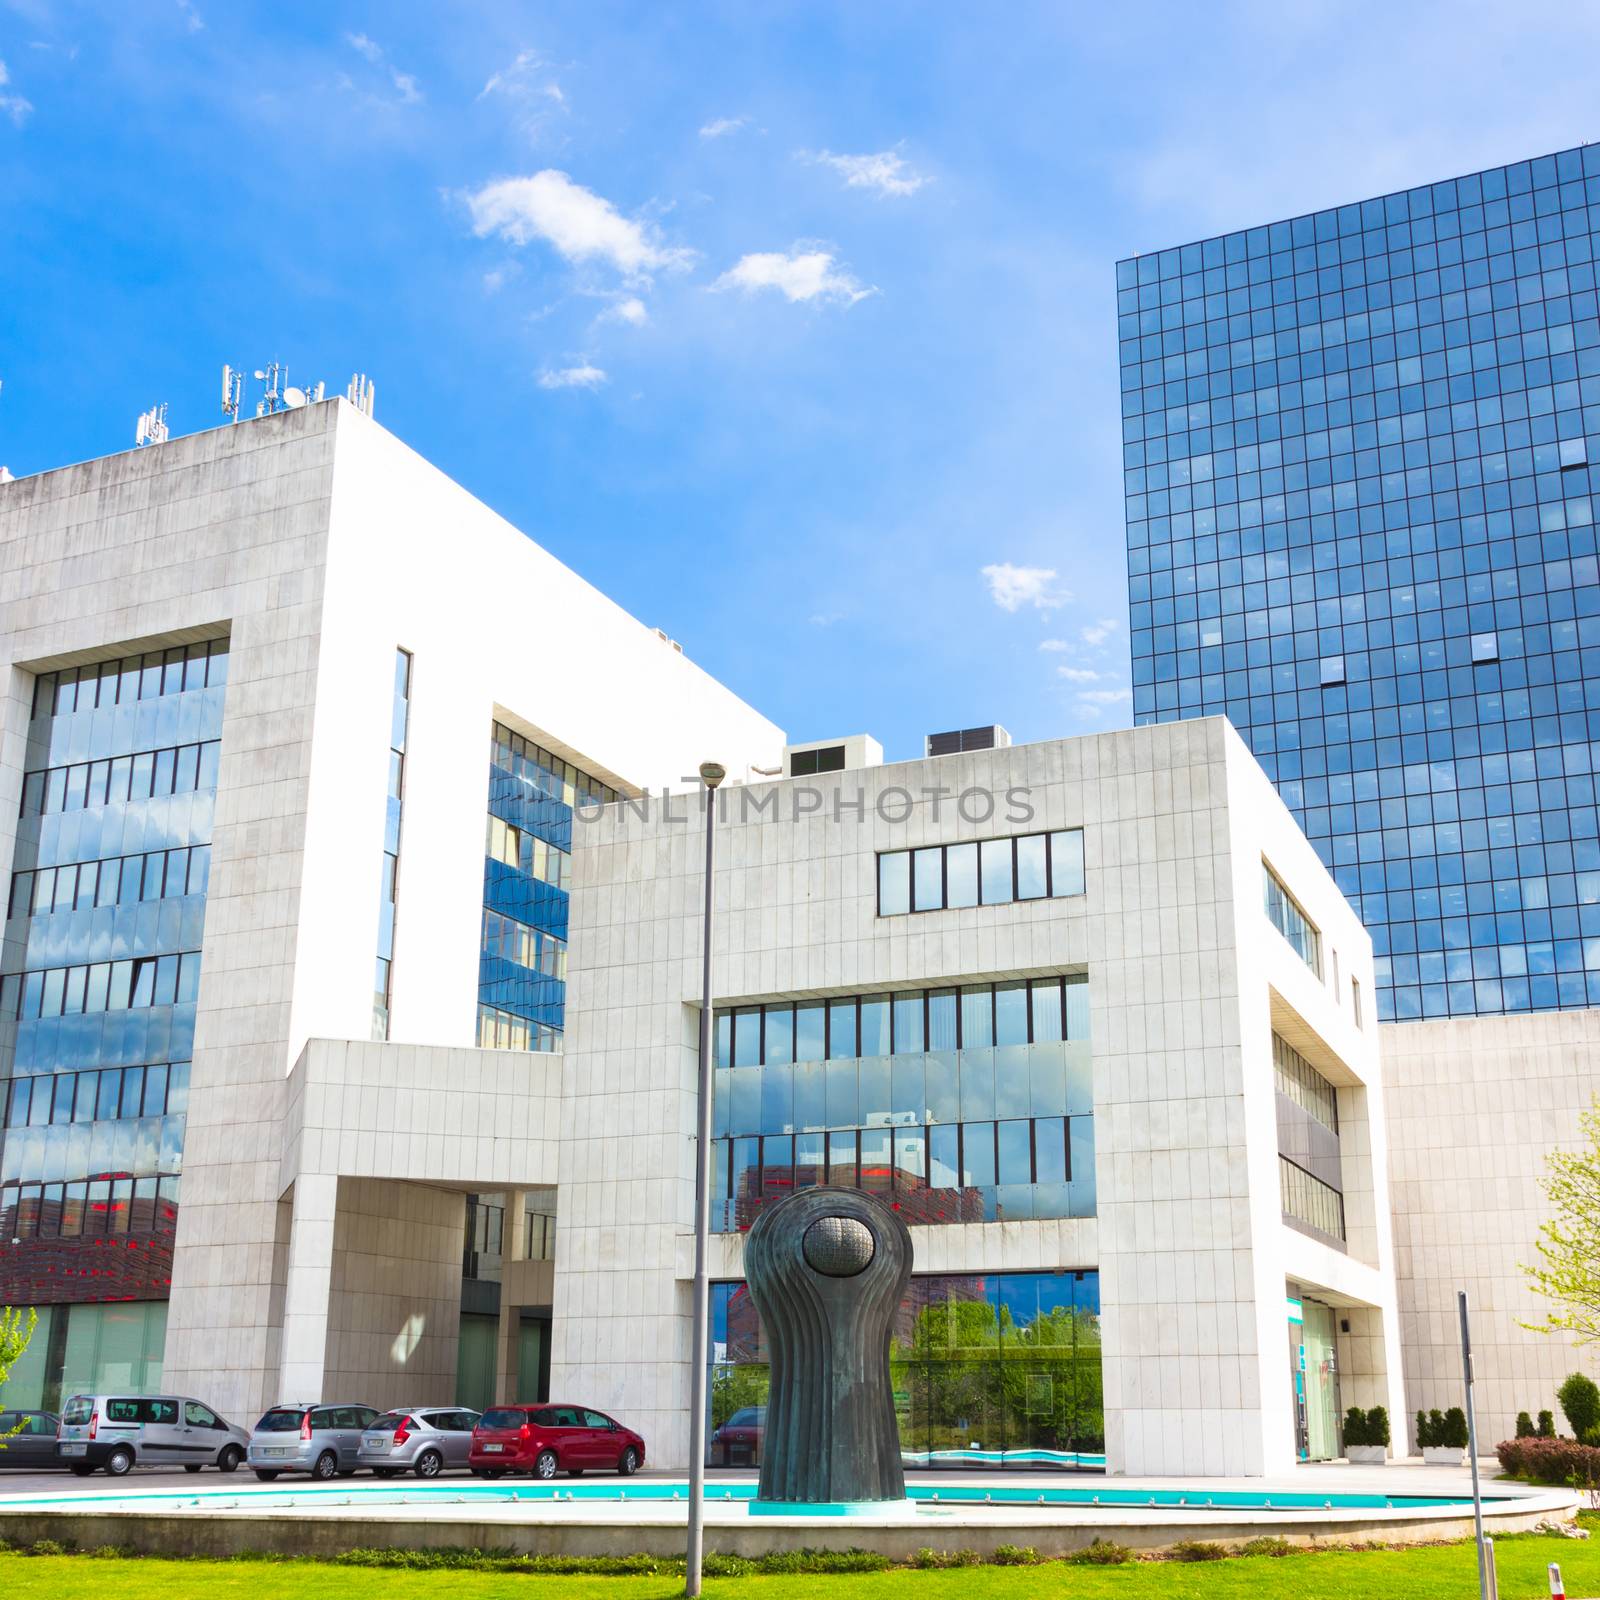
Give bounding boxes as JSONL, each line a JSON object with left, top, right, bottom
{"left": 0, "top": 640, "right": 229, "bottom": 1312}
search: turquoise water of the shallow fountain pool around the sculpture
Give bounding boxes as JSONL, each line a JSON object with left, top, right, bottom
{"left": 0, "top": 1478, "right": 1506, "bottom": 1517}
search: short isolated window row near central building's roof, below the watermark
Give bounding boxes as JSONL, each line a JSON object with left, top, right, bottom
{"left": 878, "top": 827, "right": 1083, "bottom": 917}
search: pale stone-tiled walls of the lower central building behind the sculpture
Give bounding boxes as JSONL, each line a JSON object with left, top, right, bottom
{"left": 552, "top": 718, "right": 1398, "bottom": 1474}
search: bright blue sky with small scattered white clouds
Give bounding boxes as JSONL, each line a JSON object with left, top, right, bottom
{"left": 0, "top": 0, "right": 1600, "bottom": 758}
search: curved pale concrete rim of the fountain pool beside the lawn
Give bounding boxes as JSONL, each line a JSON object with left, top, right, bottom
{"left": 0, "top": 1483, "right": 1578, "bottom": 1558}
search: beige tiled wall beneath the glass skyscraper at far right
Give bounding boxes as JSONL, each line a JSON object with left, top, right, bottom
{"left": 1381, "top": 1010, "right": 1600, "bottom": 1446}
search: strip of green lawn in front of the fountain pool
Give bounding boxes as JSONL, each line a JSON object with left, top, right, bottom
{"left": 0, "top": 1536, "right": 1600, "bottom": 1600}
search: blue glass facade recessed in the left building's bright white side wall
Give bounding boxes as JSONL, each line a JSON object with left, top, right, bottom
{"left": 478, "top": 723, "right": 618, "bottom": 1050}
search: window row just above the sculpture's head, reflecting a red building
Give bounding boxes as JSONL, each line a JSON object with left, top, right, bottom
{"left": 712, "top": 1117, "right": 1094, "bottom": 1232}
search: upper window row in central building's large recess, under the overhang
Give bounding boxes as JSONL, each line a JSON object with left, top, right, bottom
{"left": 715, "top": 976, "right": 1090, "bottom": 1067}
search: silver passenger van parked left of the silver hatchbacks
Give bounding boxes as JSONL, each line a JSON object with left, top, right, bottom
{"left": 56, "top": 1394, "right": 250, "bottom": 1478}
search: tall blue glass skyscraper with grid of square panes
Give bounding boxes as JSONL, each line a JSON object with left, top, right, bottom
{"left": 1117, "top": 146, "right": 1600, "bottom": 1021}
